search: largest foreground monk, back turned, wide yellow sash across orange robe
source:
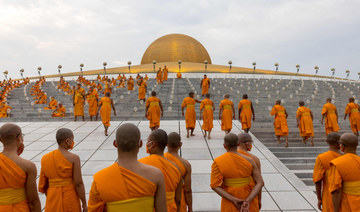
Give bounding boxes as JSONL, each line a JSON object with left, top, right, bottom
{"left": 88, "top": 123, "right": 166, "bottom": 212}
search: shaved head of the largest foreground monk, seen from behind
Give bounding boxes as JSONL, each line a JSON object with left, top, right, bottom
{"left": 116, "top": 123, "right": 141, "bottom": 152}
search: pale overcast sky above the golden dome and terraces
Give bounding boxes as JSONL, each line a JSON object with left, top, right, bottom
{"left": 0, "top": 0, "right": 360, "bottom": 79}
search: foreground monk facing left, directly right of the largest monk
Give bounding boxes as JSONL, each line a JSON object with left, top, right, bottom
{"left": 139, "top": 129, "right": 183, "bottom": 212}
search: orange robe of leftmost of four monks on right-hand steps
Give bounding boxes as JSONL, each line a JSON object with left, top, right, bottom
{"left": 270, "top": 105, "right": 289, "bottom": 136}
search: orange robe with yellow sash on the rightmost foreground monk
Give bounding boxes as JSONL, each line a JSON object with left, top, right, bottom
{"left": 329, "top": 153, "right": 360, "bottom": 212}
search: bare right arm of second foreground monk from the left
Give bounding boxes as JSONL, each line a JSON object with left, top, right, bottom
{"left": 73, "top": 155, "right": 87, "bottom": 209}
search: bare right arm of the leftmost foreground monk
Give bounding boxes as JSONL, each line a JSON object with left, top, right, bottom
{"left": 25, "top": 163, "right": 41, "bottom": 212}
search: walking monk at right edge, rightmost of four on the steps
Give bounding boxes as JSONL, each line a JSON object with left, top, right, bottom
{"left": 344, "top": 97, "right": 360, "bottom": 136}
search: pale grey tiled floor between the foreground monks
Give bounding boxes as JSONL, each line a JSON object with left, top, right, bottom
{"left": 0, "top": 121, "right": 316, "bottom": 211}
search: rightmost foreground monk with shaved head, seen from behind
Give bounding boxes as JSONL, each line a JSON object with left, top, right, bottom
{"left": 329, "top": 133, "right": 360, "bottom": 212}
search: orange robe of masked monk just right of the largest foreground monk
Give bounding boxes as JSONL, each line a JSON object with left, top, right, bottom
{"left": 139, "top": 155, "right": 181, "bottom": 212}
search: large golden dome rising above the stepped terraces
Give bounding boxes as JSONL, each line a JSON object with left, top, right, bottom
{"left": 141, "top": 34, "right": 211, "bottom": 64}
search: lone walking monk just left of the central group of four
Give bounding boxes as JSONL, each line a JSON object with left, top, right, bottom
{"left": 145, "top": 91, "right": 164, "bottom": 131}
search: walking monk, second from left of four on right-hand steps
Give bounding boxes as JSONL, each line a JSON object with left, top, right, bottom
{"left": 296, "top": 101, "right": 314, "bottom": 146}
